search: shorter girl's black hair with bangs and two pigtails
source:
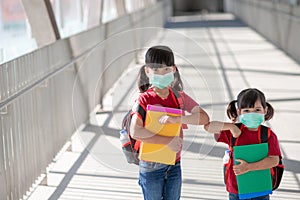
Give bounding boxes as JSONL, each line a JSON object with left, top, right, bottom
{"left": 227, "top": 88, "right": 274, "bottom": 120}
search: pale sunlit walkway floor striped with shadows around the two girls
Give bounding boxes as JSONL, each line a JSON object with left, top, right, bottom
{"left": 28, "top": 14, "right": 300, "bottom": 200}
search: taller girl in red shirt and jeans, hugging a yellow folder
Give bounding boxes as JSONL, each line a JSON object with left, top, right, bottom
{"left": 130, "top": 46, "right": 209, "bottom": 200}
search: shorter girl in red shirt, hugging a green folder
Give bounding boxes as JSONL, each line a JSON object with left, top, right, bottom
{"left": 204, "top": 88, "right": 281, "bottom": 200}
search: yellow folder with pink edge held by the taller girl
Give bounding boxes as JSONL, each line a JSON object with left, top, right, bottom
{"left": 140, "top": 105, "right": 182, "bottom": 165}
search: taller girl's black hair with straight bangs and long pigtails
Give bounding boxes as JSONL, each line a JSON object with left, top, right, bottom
{"left": 137, "top": 46, "right": 183, "bottom": 92}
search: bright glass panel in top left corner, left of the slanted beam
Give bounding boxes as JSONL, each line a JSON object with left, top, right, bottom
{"left": 0, "top": 0, "right": 37, "bottom": 64}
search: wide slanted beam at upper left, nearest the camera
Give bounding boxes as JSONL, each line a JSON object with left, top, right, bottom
{"left": 22, "top": 0, "right": 60, "bottom": 47}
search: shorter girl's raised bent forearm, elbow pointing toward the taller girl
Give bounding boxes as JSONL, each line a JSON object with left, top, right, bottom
{"left": 204, "top": 121, "right": 241, "bottom": 138}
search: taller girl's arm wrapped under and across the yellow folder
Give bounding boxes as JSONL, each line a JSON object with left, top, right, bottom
{"left": 130, "top": 114, "right": 182, "bottom": 152}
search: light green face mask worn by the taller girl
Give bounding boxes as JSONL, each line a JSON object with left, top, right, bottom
{"left": 149, "top": 72, "right": 174, "bottom": 89}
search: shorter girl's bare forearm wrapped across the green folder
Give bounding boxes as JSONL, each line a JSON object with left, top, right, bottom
{"left": 233, "top": 156, "right": 279, "bottom": 175}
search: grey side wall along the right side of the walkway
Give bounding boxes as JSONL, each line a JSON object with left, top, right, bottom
{"left": 224, "top": 0, "right": 300, "bottom": 62}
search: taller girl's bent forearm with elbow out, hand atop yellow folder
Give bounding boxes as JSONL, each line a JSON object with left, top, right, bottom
{"left": 159, "top": 106, "right": 209, "bottom": 125}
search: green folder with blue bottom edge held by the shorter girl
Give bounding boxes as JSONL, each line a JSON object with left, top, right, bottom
{"left": 233, "top": 143, "right": 272, "bottom": 199}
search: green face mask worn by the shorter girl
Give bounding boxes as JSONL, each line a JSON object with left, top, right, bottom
{"left": 239, "top": 113, "right": 265, "bottom": 128}
